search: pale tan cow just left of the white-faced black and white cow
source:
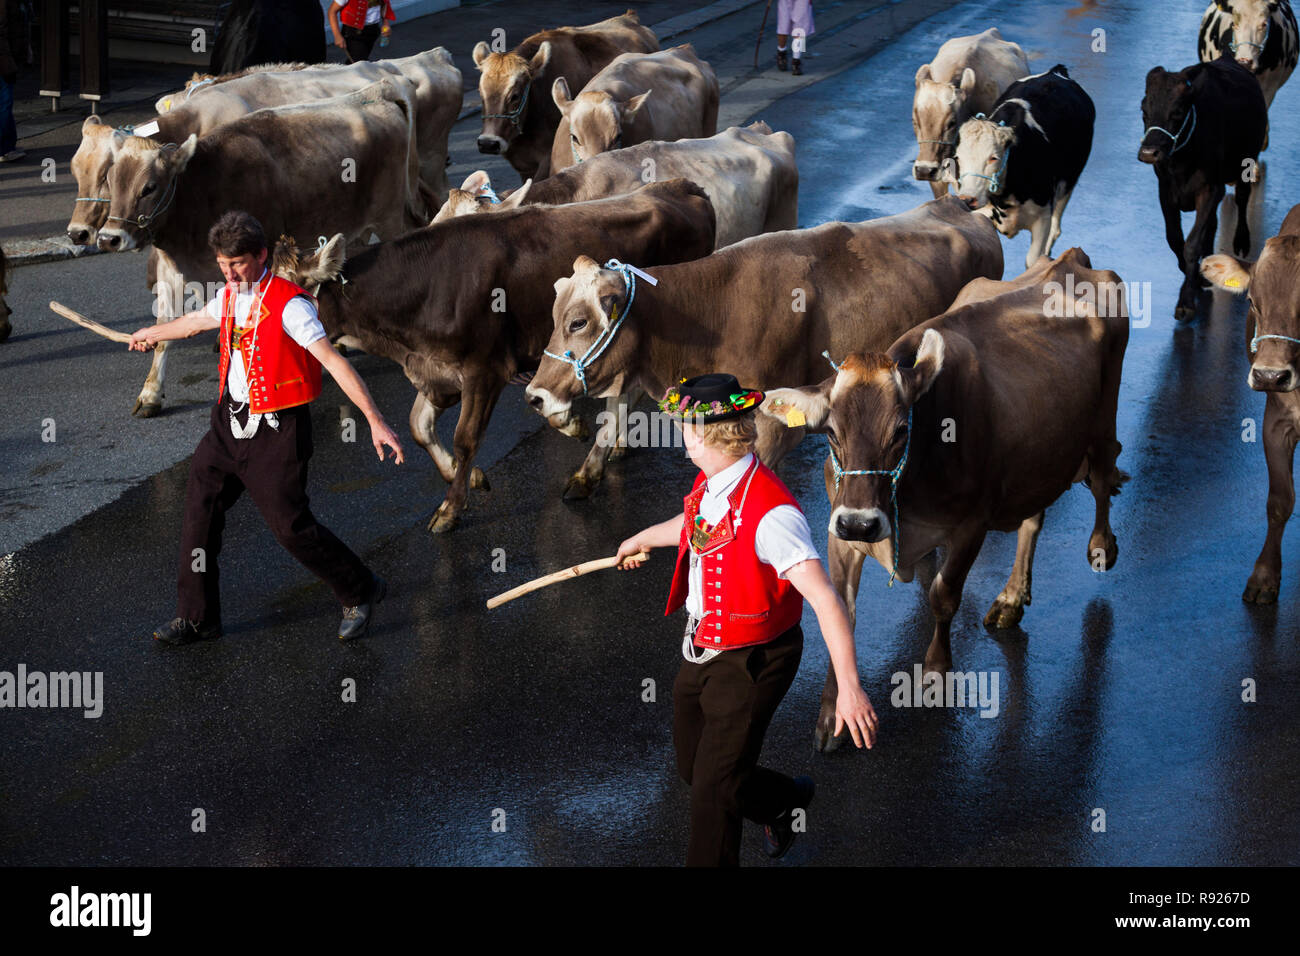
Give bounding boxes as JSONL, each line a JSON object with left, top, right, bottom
{"left": 911, "top": 27, "right": 1030, "bottom": 196}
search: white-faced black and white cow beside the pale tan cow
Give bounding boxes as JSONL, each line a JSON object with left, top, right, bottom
{"left": 948, "top": 64, "right": 1097, "bottom": 268}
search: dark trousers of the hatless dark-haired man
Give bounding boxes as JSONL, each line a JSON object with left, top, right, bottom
{"left": 177, "top": 392, "right": 373, "bottom": 623}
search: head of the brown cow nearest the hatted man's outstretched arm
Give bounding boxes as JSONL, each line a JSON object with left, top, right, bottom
{"left": 761, "top": 329, "right": 944, "bottom": 544}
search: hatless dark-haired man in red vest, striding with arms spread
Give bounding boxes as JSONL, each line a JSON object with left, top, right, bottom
{"left": 129, "top": 212, "right": 403, "bottom": 644}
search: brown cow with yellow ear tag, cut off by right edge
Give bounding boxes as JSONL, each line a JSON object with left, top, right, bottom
{"left": 1201, "top": 206, "right": 1300, "bottom": 604}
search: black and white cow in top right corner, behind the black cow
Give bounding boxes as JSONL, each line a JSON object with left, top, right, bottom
{"left": 1197, "top": 0, "right": 1300, "bottom": 107}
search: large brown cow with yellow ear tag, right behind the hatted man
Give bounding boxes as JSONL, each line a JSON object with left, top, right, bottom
{"left": 762, "top": 248, "right": 1128, "bottom": 749}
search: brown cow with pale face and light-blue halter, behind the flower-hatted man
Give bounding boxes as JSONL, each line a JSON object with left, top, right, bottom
{"left": 528, "top": 196, "right": 1002, "bottom": 494}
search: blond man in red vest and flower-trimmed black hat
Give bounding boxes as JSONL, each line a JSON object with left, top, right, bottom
{"left": 619, "top": 375, "right": 876, "bottom": 866}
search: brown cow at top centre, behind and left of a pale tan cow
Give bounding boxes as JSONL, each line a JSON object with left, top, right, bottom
{"left": 473, "top": 10, "right": 659, "bottom": 180}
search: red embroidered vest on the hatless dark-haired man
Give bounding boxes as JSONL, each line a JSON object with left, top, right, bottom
{"left": 217, "top": 276, "right": 321, "bottom": 412}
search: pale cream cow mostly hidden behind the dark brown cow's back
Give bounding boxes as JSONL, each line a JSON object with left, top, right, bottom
{"left": 438, "top": 122, "right": 800, "bottom": 248}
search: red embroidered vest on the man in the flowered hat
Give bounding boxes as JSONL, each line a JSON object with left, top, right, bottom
{"left": 664, "top": 458, "right": 803, "bottom": 650}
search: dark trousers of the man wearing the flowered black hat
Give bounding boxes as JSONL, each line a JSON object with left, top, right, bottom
{"left": 672, "top": 624, "right": 803, "bottom": 866}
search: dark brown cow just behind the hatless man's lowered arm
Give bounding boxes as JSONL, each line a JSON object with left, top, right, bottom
{"left": 278, "top": 179, "right": 714, "bottom": 532}
